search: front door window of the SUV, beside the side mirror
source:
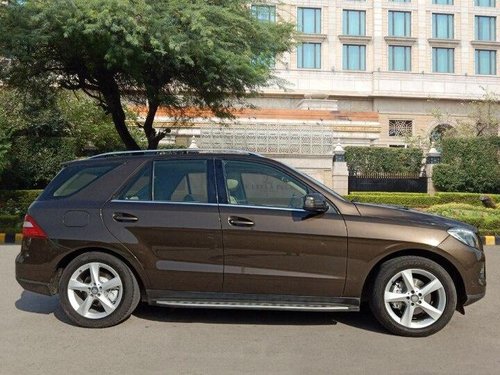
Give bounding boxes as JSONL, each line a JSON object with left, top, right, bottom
{"left": 224, "top": 161, "right": 308, "bottom": 208}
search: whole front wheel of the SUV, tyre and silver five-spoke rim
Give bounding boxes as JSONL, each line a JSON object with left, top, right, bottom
{"left": 370, "top": 256, "right": 457, "bottom": 337}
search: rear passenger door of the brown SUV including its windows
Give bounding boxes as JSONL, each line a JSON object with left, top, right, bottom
{"left": 103, "top": 156, "right": 223, "bottom": 292}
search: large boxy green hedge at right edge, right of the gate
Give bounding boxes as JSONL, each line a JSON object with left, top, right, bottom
{"left": 432, "top": 137, "right": 500, "bottom": 193}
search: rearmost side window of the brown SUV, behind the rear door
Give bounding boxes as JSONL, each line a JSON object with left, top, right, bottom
{"left": 47, "top": 163, "right": 119, "bottom": 198}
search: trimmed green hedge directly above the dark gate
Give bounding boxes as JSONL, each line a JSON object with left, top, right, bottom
{"left": 345, "top": 146, "right": 423, "bottom": 174}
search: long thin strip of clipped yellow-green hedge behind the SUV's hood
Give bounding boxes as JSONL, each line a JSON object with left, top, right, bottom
{"left": 346, "top": 192, "right": 500, "bottom": 208}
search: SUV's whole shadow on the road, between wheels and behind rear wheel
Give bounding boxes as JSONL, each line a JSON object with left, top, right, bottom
{"left": 15, "top": 291, "right": 387, "bottom": 334}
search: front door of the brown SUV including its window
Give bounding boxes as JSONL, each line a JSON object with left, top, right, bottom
{"left": 217, "top": 159, "right": 347, "bottom": 297}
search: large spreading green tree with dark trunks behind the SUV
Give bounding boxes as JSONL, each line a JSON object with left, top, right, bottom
{"left": 0, "top": 0, "right": 293, "bottom": 150}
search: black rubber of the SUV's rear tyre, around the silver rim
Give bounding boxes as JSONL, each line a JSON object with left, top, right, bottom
{"left": 59, "top": 252, "right": 141, "bottom": 328}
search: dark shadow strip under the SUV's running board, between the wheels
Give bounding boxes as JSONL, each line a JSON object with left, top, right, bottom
{"left": 134, "top": 304, "right": 387, "bottom": 334}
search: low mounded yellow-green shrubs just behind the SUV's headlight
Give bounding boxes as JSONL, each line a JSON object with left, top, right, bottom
{"left": 426, "top": 203, "right": 500, "bottom": 235}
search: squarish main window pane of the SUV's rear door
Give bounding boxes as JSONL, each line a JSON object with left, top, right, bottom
{"left": 153, "top": 160, "right": 208, "bottom": 203}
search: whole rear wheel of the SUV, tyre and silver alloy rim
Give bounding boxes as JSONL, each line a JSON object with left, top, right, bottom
{"left": 59, "top": 252, "right": 141, "bottom": 328}
